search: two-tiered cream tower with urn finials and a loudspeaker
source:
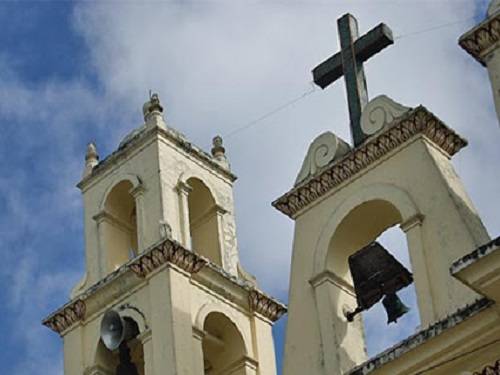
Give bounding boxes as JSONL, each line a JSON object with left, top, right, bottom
{"left": 44, "top": 94, "right": 286, "bottom": 375}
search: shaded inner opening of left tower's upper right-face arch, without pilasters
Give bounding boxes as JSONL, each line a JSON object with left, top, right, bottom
{"left": 187, "top": 178, "right": 222, "bottom": 266}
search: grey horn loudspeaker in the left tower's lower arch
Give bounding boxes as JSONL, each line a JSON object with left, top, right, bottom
{"left": 101, "top": 310, "right": 139, "bottom": 350}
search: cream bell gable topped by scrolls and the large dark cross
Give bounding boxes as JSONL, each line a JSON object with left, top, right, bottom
{"left": 273, "top": 14, "right": 489, "bottom": 375}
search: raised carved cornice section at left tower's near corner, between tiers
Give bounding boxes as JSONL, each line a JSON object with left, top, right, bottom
{"left": 129, "top": 238, "right": 208, "bottom": 277}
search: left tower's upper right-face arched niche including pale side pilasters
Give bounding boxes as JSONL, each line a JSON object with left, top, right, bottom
{"left": 178, "top": 177, "right": 225, "bottom": 267}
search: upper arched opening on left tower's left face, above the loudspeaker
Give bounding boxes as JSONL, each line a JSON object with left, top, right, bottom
{"left": 94, "top": 179, "right": 142, "bottom": 274}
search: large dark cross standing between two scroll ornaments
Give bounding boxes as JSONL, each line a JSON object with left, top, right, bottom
{"left": 313, "top": 13, "right": 394, "bottom": 146}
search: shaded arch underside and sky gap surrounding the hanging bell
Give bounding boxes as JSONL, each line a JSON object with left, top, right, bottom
{"left": 327, "top": 199, "right": 420, "bottom": 356}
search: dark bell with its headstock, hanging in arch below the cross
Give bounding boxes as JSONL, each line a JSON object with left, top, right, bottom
{"left": 346, "top": 242, "right": 413, "bottom": 324}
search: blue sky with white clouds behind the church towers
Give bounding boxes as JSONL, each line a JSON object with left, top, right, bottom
{"left": 0, "top": 0, "right": 500, "bottom": 375}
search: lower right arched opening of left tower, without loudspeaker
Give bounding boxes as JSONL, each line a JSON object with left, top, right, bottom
{"left": 202, "top": 312, "right": 248, "bottom": 375}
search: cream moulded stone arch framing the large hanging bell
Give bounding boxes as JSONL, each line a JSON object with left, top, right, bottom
{"left": 310, "top": 184, "right": 422, "bottom": 372}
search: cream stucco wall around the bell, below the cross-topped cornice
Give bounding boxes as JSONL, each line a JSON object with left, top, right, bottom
{"left": 284, "top": 136, "right": 489, "bottom": 375}
